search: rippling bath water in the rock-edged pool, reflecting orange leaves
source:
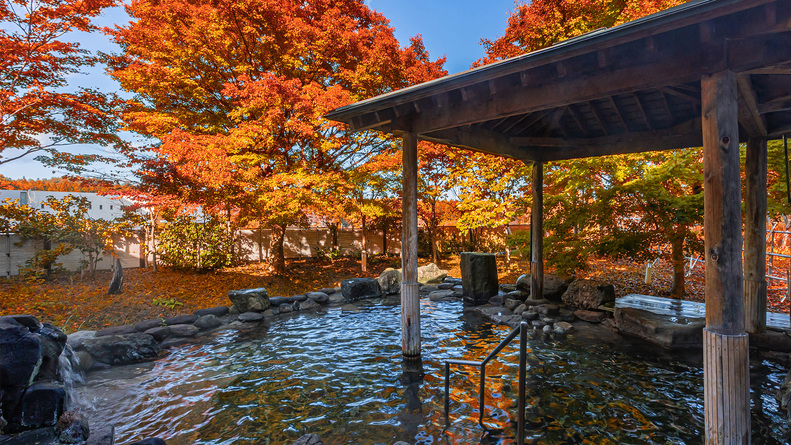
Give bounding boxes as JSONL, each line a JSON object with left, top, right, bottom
{"left": 71, "top": 300, "right": 788, "bottom": 445}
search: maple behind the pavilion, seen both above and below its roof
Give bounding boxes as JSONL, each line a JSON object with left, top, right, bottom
{"left": 476, "top": 0, "right": 702, "bottom": 296}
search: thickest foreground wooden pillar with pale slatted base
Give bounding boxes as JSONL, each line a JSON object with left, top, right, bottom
{"left": 701, "top": 70, "right": 750, "bottom": 445}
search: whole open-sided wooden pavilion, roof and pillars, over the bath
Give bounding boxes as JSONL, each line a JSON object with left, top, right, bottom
{"left": 327, "top": 0, "right": 791, "bottom": 444}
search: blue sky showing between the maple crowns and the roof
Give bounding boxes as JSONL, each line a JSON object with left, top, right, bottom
{"left": 0, "top": 0, "right": 515, "bottom": 179}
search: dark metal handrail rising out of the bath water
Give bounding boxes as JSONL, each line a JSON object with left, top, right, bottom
{"left": 445, "top": 321, "right": 528, "bottom": 444}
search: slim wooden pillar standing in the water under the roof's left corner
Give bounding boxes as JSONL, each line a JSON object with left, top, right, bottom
{"left": 401, "top": 133, "right": 420, "bottom": 357}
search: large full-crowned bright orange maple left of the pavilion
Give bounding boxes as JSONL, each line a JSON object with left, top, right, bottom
{"left": 109, "top": 0, "right": 443, "bottom": 271}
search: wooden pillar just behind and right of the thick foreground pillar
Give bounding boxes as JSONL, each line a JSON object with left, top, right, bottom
{"left": 744, "top": 137, "right": 767, "bottom": 334}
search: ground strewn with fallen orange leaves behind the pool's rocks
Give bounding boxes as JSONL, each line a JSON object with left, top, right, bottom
{"left": 0, "top": 253, "right": 789, "bottom": 332}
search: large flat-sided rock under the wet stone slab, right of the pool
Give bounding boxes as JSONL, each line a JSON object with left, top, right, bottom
{"left": 615, "top": 307, "right": 706, "bottom": 349}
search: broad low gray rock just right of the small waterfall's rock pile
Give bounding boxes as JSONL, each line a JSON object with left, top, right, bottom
{"left": 83, "top": 333, "right": 159, "bottom": 365}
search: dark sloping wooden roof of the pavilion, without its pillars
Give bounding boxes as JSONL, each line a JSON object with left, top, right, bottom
{"left": 327, "top": 0, "right": 791, "bottom": 161}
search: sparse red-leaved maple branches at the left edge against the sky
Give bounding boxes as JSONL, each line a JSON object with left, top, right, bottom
{"left": 0, "top": 0, "right": 123, "bottom": 170}
